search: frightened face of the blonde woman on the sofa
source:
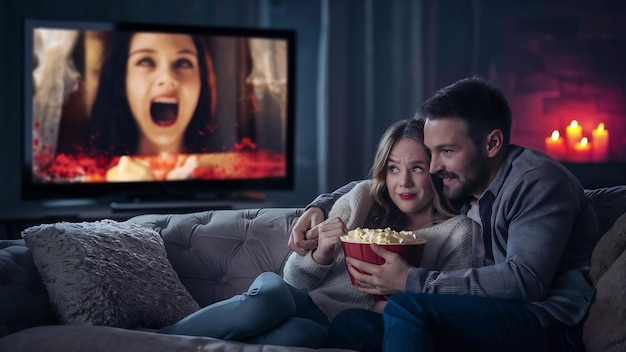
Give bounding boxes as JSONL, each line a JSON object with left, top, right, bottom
{"left": 385, "top": 138, "right": 433, "bottom": 218}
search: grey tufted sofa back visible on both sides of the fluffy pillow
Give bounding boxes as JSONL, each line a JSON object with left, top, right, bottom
{"left": 0, "top": 208, "right": 302, "bottom": 338}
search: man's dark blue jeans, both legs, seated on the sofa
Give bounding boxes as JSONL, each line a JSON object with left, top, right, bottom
{"left": 327, "top": 294, "right": 582, "bottom": 352}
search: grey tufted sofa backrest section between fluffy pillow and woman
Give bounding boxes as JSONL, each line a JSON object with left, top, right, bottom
{"left": 129, "top": 208, "right": 302, "bottom": 306}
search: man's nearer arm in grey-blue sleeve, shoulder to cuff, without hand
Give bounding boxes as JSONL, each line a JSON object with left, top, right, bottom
{"left": 406, "top": 170, "right": 598, "bottom": 302}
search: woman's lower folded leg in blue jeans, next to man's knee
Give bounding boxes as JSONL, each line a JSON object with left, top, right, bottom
{"left": 244, "top": 317, "right": 328, "bottom": 348}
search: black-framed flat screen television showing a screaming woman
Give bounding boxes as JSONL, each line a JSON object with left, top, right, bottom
{"left": 21, "top": 19, "right": 296, "bottom": 208}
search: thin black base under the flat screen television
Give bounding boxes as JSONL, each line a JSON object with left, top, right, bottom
{"left": 111, "top": 200, "right": 233, "bottom": 213}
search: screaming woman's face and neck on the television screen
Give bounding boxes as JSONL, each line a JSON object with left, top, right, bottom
{"left": 126, "top": 33, "right": 201, "bottom": 154}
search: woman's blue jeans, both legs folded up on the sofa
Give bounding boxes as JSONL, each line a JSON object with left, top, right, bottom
{"left": 158, "top": 273, "right": 329, "bottom": 348}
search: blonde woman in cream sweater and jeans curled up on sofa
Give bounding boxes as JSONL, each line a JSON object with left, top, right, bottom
{"left": 154, "top": 120, "right": 473, "bottom": 348}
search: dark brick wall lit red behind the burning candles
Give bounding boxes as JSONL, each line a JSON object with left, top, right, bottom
{"left": 479, "top": 0, "right": 626, "bottom": 162}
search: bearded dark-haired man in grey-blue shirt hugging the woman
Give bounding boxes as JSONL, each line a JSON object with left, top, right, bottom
{"left": 289, "top": 78, "right": 600, "bottom": 351}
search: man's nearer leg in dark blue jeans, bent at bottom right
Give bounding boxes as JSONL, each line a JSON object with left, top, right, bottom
{"left": 383, "top": 294, "right": 548, "bottom": 352}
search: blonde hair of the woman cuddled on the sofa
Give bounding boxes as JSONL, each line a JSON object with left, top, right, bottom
{"left": 367, "top": 119, "right": 458, "bottom": 230}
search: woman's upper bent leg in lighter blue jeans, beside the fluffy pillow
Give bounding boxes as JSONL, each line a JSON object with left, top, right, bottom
{"left": 158, "top": 272, "right": 295, "bottom": 341}
